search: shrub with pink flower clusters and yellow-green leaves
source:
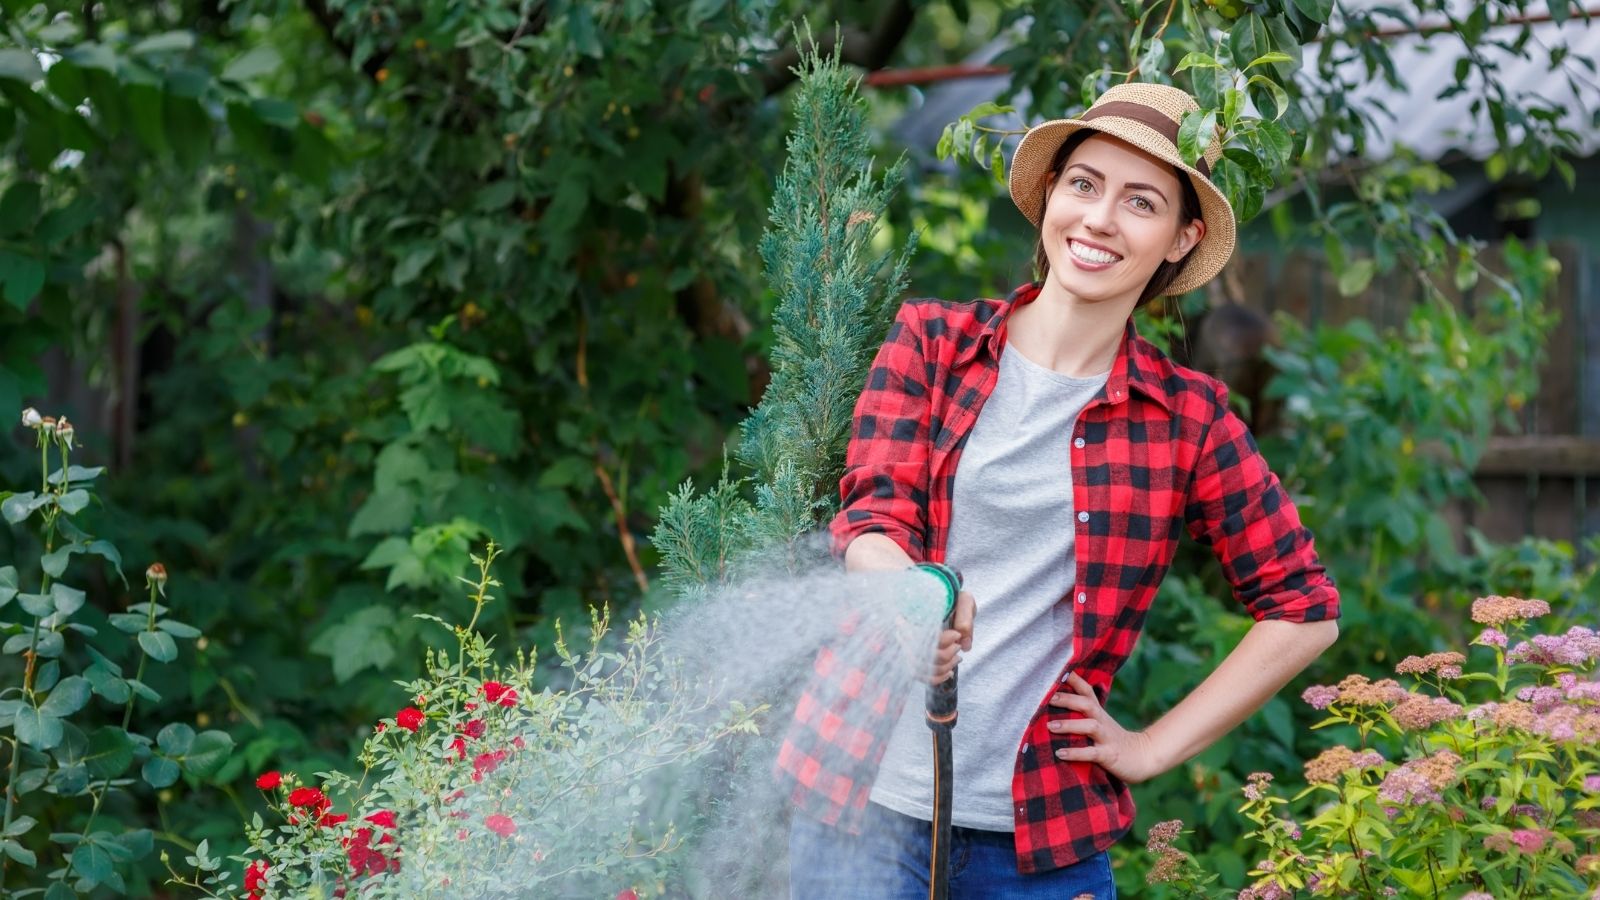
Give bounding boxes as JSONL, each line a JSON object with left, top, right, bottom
{"left": 1149, "top": 596, "right": 1600, "bottom": 900}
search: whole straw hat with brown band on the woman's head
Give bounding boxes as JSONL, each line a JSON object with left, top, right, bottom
{"left": 1011, "top": 83, "right": 1237, "bottom": 295}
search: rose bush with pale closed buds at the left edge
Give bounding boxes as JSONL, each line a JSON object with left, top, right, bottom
{"left": 0, "top": 408, "right": 234, "bottom": 900}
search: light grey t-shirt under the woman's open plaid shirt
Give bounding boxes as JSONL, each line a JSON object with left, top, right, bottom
{"left": 872, "top": 341, "right": 1110, "bottom": 831}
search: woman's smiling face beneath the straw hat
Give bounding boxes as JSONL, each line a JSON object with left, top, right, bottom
{"left": 1040, "top": 135, "right": 1205, "bottom": 312}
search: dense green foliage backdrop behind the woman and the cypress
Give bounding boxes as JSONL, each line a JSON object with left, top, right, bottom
{"left": 0, "top": 0, "right": 1597, "bottom": 887}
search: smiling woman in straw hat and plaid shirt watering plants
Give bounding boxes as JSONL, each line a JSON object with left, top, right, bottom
{"left": 779, "top": 85, "right": 1339, "bottom": 900}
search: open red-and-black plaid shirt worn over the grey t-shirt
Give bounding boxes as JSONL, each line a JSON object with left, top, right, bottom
{"left": 778, "top": 285, "right": 1339, "bottom": 873}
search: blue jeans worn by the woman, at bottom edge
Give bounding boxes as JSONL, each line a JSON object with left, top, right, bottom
{"left": 789, "top": 804, "right": 1117, "bottom": 900}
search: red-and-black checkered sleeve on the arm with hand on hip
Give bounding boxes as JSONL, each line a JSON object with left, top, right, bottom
{"left": 1184, "top": 384, "right": 1339, "bottom": 621}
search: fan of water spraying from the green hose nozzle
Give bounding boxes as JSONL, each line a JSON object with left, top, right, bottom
{"left": 348, "top": 538, "right": 944, "bottom": 898}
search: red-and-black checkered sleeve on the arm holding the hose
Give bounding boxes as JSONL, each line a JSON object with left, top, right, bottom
{"left": 829, "top": 303, "right": 930, "bottom": 562}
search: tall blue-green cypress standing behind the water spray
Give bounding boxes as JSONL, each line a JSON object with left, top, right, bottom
{"left": 651, "top": 40, "right": 915, "bottom": 596}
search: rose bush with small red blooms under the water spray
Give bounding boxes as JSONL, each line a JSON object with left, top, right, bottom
{"left": 168, "top": 544, "right": 762, "bottom": 900}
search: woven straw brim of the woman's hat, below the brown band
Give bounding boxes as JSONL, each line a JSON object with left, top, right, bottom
{"left": 1010, "top": 115, "right": 1238, "bottom": 295}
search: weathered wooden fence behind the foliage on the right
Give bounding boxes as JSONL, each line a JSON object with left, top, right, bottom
{"left": 1230, "top": 242, "right": 1600, "bottom": 543}
